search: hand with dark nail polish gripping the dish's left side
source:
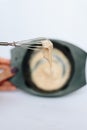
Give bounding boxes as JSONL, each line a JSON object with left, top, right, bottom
{"left": 0, "top": 58, "right": 17, "bottom": 91}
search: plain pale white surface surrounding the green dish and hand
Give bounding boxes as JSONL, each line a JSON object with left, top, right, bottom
{"left": 0, "top": 0, "right": 87, "bottom": 130}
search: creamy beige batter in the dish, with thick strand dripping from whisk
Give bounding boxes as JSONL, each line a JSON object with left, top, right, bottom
{"left": 30, "top": 41, "right": 71, "bottom": 91}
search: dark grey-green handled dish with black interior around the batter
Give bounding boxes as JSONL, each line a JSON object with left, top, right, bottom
{"left": 11, "top": 39, "right": 87, "bottom": 97}
